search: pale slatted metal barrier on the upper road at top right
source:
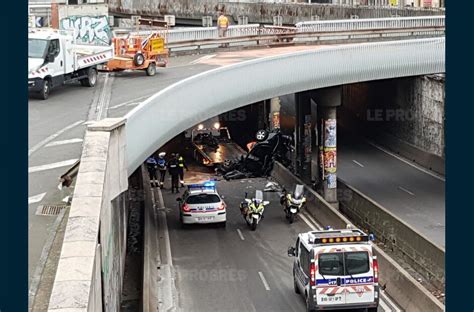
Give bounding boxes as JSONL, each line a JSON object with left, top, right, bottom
{"left": 296, "top": 16, "right": 445, "bottom": 32}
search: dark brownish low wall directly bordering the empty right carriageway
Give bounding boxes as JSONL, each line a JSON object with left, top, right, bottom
{"left": 337, "top": 179, "right": 445, "bottom": 289}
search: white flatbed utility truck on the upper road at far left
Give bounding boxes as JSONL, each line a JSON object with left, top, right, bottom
{"left": 28, "top": 28, "right": 113, "bottom": 100}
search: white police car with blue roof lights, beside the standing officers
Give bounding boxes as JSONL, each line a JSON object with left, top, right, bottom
{"left": 176, "top": 181, "right": 226, "bottom": 226}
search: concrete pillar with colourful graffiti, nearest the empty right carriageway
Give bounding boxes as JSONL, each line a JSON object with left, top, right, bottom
{"left": 311, "top": 86, "right": 342, "bottom": 204}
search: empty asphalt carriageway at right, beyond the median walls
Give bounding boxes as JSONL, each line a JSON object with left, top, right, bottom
{"left": 337, "top": 129, "right": 446, "bottom": 247}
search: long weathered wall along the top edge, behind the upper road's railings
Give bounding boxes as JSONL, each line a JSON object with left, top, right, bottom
{"left": 109, "top": 0, "right": 444, "bottom": 24}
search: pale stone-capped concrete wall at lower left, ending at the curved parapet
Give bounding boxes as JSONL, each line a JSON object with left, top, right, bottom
{"left": 48, "top": 119, "right": 128, "bottom": 312}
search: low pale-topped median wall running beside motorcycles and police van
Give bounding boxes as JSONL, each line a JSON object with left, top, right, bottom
{"left": 272, "top": 163, "right": 444, "bottom": 312}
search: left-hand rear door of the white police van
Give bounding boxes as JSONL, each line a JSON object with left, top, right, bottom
{"left": 315, "top": 249, "right": 346, "bottom": 306}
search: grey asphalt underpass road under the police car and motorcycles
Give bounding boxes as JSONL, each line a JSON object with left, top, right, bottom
{"left": 159, "top": 174, "right": 396, "bottom": 312}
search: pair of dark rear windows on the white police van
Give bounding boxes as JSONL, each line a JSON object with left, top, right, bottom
{"left": 318, "top": 251, "right": 369, "bottom": 275}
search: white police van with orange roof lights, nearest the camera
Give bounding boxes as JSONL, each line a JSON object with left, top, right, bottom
{"left": 288, "top": 229, "right": 379, "bottom": 312}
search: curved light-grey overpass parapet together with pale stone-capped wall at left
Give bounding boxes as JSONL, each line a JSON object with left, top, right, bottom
{"left": 43, "top": 38, "right": 445, "bottom": 311}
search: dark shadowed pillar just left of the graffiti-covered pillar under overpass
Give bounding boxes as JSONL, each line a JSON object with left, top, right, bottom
{"left": 295, "top": 92, "right": 312, "bottom": 184}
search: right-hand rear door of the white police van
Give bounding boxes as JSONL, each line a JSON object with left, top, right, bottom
{"left": 344, "top": 248, "right": 375, "bottom": 304}
